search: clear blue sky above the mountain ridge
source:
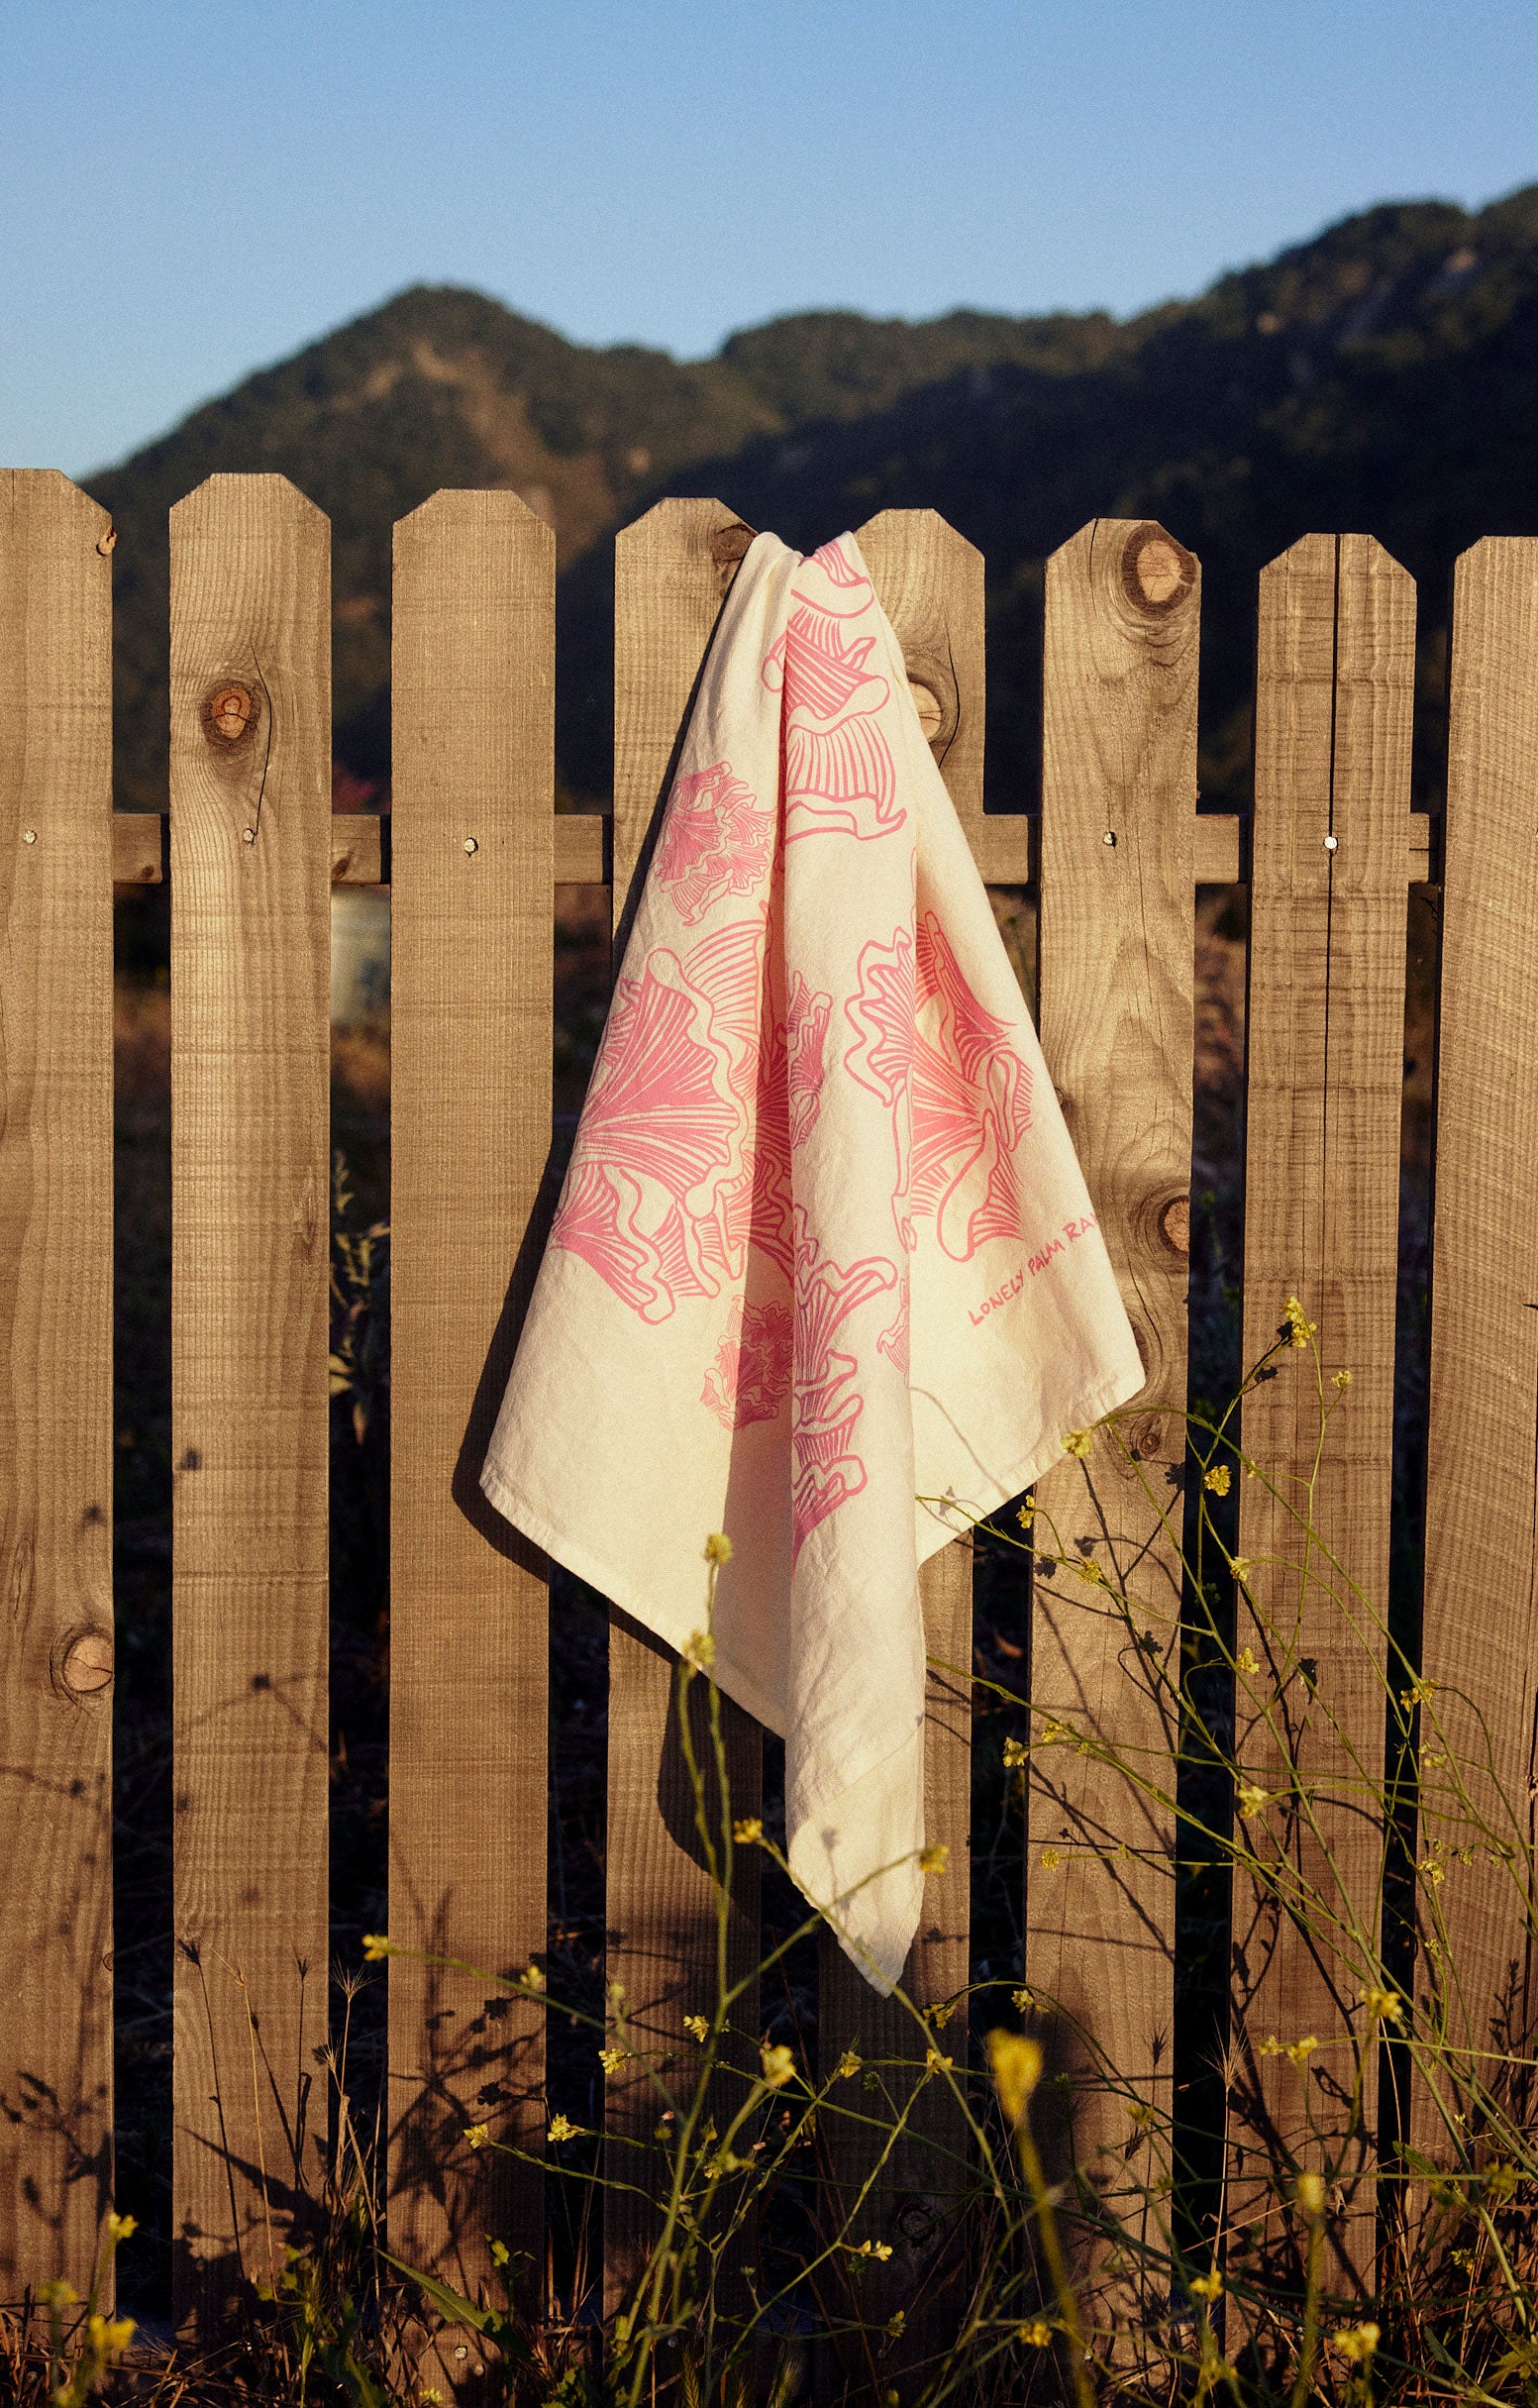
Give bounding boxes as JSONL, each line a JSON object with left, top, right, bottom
{"left": 0, "top": 0, "right": 1538, "bottom": 474}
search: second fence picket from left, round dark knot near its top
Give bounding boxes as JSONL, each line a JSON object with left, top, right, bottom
{"left": 171, "top": 476, "right": 332, "bottom": 2326}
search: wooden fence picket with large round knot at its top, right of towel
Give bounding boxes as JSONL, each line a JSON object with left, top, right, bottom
{"left": 1025, "top": 518, "right": 1198, "bottom": 2319}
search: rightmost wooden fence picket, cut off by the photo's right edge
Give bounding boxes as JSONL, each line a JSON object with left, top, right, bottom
{"left": 1413, "top": 537, "right": 1538, "bottom": 2164}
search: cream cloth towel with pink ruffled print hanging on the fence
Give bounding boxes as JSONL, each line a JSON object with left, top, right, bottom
{"left": 481, "top": 535, "right": 1143, "bottom": 1989}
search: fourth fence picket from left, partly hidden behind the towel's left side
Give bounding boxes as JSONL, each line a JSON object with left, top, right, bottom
{"left": 604, "top": 501, "right": 763, "bottom": 2309}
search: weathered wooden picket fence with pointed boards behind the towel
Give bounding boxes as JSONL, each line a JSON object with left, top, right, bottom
{"left": 0, "top": 471, "right": 1538, "bottom": 2350}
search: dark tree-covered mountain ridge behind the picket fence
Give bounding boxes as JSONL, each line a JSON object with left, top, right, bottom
{"left": 86, "top": 185, "right": 1538, "bottom": 809}
